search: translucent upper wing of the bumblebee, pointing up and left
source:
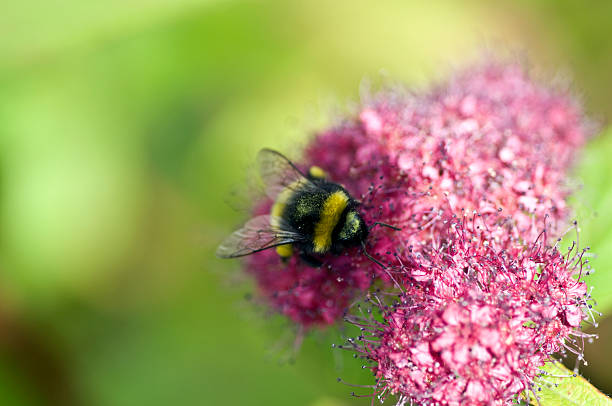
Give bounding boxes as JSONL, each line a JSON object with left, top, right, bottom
{"left": 257, "top": 148, "right": 316, "bottom": 199}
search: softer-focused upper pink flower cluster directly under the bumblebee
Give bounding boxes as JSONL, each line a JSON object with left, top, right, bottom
{"left": 246, "top": 64, "right": 588, "bottom": 334}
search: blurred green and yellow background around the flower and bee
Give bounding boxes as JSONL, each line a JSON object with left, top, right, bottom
{"left": 0, "top": 0, "right": 612, "bottom": 406}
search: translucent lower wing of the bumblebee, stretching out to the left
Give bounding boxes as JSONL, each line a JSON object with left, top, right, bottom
{"left": 217, "top": 214, "right": 304, "bottom": 258}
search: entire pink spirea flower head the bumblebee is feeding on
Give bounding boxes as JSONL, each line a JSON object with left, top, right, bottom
{"left": 247, "top": 64, "right": 590, "bottom": 404}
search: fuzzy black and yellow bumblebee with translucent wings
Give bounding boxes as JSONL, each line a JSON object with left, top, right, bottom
{"left": 217, "top": 149, "right": 399, "bottom": 267}
